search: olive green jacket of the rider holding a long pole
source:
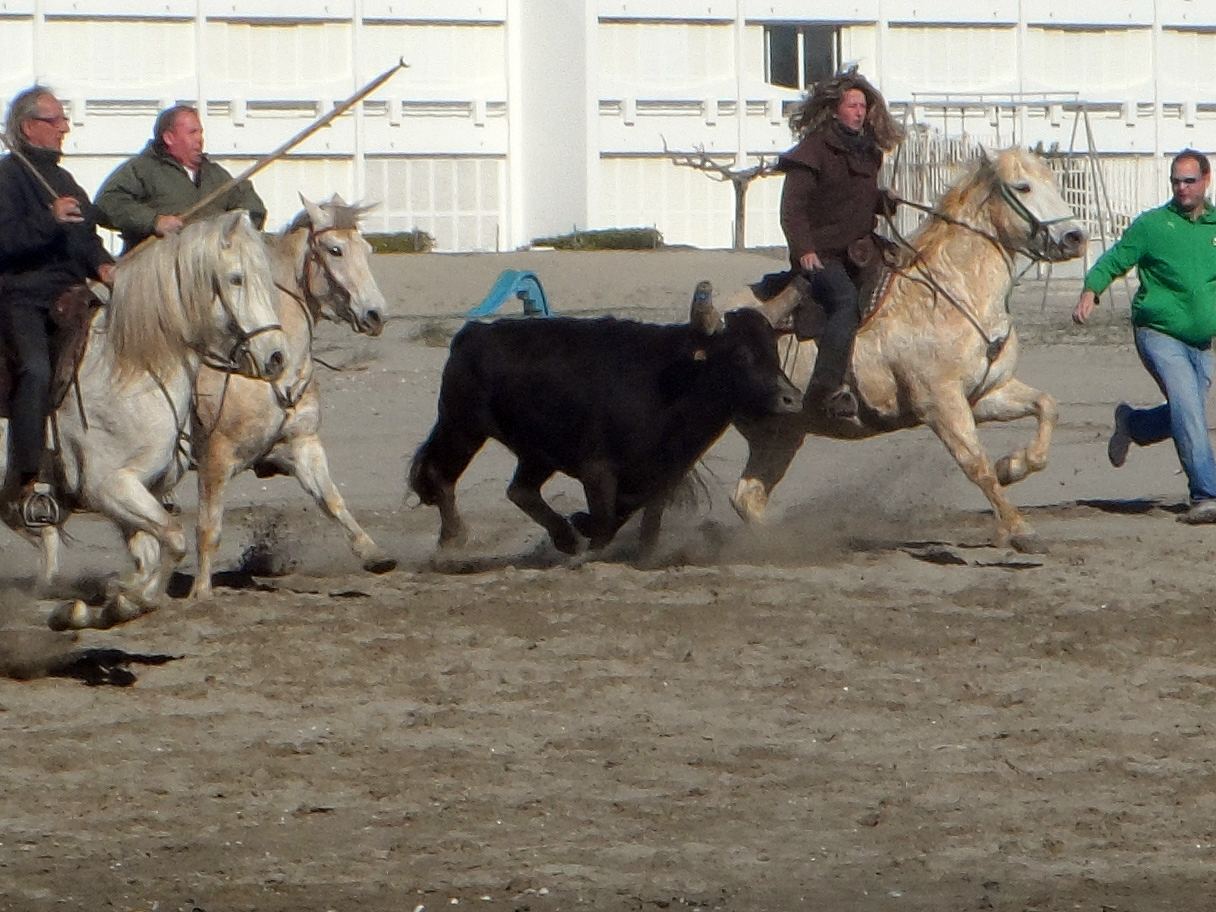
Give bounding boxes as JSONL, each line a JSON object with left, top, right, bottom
{"left": 95, "top": 142, "right": 266, "bottom": 253}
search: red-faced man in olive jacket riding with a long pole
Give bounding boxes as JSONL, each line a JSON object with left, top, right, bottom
{"left": 96, "top": 105, "right": 266, "bottom": 253}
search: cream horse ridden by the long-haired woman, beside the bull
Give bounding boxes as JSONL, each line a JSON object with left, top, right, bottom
{"left": 731, "top": 150, "right": 1087, "bottom": 551}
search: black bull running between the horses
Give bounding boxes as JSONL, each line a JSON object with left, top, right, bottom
{"left": 409, "top": 282, "right": 801, "bottom": 554}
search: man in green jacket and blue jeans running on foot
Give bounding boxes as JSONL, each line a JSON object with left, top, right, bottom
{"left": 1073, "top": 148, "right": 1216, "bottom": 523}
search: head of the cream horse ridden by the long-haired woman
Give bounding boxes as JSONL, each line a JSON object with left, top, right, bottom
{"left": 961, "top": 148, "right": 1088, "bottom": 263}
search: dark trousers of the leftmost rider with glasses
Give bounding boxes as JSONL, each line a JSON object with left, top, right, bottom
{"left": 0, "top": 300, "right": 51, "bottom": 484}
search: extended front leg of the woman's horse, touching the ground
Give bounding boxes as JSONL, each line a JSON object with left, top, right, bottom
{"left": 923, "top": 392, "right": 1046, "bottom": 553}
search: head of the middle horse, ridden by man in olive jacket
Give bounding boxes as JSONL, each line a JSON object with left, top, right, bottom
{"left": 295, "top": 193, "right": 388, "bottom": 336}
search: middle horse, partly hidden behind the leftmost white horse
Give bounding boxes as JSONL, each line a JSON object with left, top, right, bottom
{"left": 190, "top": 196, "right": 396, "bottom": 598}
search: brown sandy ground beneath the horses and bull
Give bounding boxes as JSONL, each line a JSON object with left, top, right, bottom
{"left": 0, "top": 250, "right": 1216, "bottom": 912}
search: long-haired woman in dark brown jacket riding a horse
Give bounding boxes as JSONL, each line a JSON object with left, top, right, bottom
{"left": 777, "top": 69, "right": 903, "bottom": 418}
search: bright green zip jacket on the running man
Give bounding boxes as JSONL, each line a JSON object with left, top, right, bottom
{"left": 1085, "top": 201, "right": 1216, "bottom": 345}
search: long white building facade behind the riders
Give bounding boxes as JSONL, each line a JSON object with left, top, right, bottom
{"left": 0, "top": 0, "right": 1216, "bottom": 250}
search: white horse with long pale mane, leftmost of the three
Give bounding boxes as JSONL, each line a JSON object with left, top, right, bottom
{"left": 5, "top": 213, "right": 300, "bottom": 627}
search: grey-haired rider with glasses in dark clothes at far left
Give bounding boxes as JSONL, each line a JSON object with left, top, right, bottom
{"left": 0, "top": 85, "right": 114, "bottom": 528}
